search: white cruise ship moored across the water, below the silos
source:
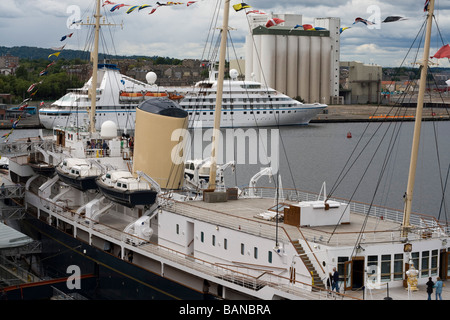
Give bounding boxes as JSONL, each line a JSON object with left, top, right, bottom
{"left": 39, "top": 64, "right": 327, "bottom": 131}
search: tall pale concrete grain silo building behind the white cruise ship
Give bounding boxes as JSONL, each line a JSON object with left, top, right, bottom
{"left": 245, "top": 15, "right": 340, "bottom": 104}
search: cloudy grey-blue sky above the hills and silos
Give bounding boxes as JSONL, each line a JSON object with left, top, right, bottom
{"left": 0, "top": 0, "right": 450, "bottom": 67}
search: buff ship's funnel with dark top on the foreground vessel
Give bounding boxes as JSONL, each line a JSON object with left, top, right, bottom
{"left": 133, "top": 98, "right": 188, "bottom": 189}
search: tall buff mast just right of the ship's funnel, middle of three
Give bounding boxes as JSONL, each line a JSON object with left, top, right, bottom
{"left": 209, "top": 0, "right": 230, "bottom": 190}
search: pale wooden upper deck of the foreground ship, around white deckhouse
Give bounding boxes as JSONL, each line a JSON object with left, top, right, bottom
{"left": 160, "top": 198, "right": 401, "bottom": 246}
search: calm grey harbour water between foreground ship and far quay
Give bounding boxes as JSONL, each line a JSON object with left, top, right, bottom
{"left": 0, "top": 121, "right": 450, "bottom": 221}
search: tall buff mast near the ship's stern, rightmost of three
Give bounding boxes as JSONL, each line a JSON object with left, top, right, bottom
{"left": 401, "top": 0, "right": 435, "bottom": 238}
